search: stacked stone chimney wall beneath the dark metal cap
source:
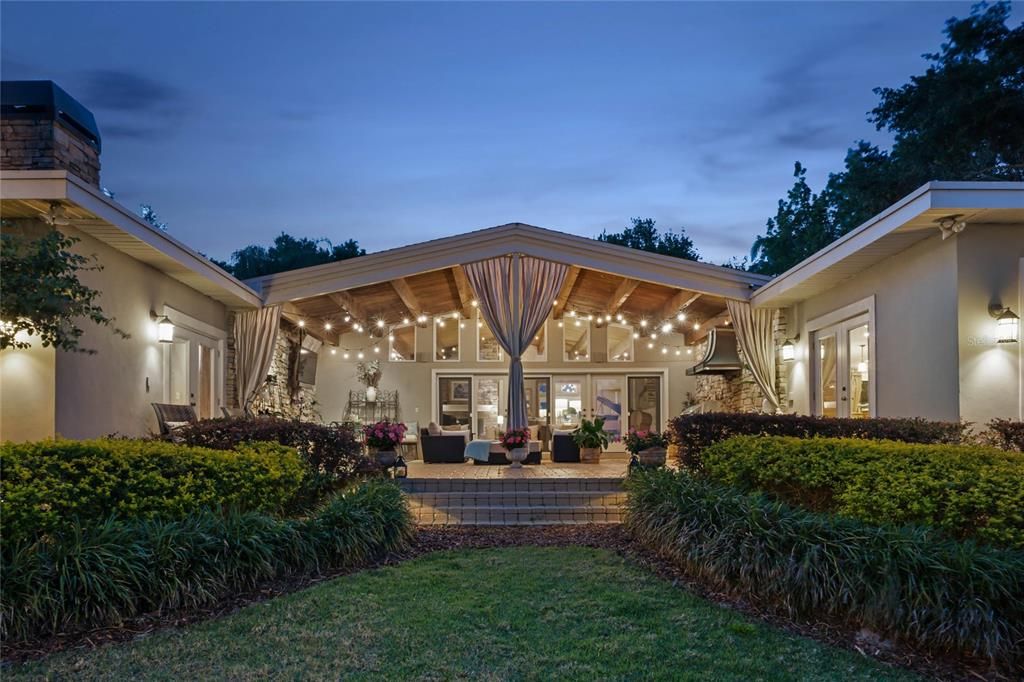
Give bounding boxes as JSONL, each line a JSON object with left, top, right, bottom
{"left": 0, "top": 118, "right": 99, "bottom": 187}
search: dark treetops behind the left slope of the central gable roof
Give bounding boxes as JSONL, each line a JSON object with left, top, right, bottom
{"left": 220, "top": 232, "right": 367, "bottom": 280}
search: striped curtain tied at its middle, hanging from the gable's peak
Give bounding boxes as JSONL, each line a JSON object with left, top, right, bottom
{"left": 464, "top": 254, "right": 569, "bottom": 429}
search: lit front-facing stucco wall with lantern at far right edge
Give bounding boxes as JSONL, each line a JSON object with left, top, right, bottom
{"left": 956, "top": 224, "right": 1024, "bottom": 423}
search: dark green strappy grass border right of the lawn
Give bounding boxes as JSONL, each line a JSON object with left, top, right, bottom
{"left": 625, "top": 470, "right": 1024, "bottom": 668}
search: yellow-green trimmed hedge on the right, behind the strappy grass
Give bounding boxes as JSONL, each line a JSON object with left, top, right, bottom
{"left": 703, "top": 436, "right": 1024, "bottom": 549}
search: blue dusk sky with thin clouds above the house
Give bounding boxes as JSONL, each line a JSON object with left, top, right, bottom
{"left": 0, "top": 2, "right": 991, "bottom": 262}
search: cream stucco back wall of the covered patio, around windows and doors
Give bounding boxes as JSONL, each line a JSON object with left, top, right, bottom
{"left": 316, "top": 311, "right": 699, "bottom": 425}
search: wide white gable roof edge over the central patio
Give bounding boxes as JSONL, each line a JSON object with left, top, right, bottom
{"left": 247, "top": 222, "right": 769, "bottom": 304}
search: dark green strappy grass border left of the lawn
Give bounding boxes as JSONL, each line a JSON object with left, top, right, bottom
{"left": 0, "top": 480, "right": 414, "bottom": 640}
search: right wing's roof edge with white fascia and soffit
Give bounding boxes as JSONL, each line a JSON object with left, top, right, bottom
{"left": 751, "top": 181, "right": 1024, "bottom": 307}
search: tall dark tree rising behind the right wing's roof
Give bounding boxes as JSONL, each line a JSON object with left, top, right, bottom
{"left": 751, "top": 2, "right": 1024, "bottom": 274}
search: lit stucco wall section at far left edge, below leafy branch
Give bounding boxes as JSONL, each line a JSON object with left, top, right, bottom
{"left": 0, "top": 336, "right": 56, "bottom": 441}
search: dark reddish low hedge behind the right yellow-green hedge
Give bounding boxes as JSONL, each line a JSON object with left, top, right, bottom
{"left": 670, "top": 412, "right": 970, "bottom": 470}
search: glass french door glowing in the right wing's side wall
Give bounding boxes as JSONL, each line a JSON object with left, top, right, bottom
{"left": 812, "top": 314, "right": 874, "bottom": 418}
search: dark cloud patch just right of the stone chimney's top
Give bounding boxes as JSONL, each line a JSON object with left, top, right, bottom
{"left": 80, "top": 69, "right": 190, "bottom": 140}
